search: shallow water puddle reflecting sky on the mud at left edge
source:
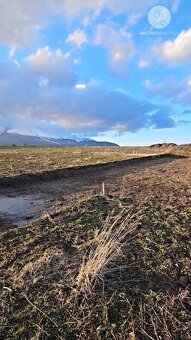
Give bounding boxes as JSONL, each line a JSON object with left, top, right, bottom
{"left": 0, "top": 195, "right": 45, "bottom": 227}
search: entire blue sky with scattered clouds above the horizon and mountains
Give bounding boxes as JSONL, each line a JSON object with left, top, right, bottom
{"left": 0, "top": 0, "right": 191, "bottom": 145}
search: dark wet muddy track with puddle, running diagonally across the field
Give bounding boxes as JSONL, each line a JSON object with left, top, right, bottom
{"left": 0, "top": 154, "right": 185, "bottom": 230}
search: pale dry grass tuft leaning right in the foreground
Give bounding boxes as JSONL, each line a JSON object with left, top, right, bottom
{"left": 75, "top": 213, "right": 136, "bottom": 295}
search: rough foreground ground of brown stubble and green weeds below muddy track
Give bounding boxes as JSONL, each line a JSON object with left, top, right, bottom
{"left": 0, "top": 155, "right": 191, "bottom": 340}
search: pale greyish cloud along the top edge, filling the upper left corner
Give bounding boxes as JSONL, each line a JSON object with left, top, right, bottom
{"left": 0, "top": 0, "right": 157, "bottom": 47}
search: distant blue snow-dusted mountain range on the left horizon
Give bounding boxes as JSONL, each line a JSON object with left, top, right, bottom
{"left": 0, "top": 131, "right": 118, "bottom": 146}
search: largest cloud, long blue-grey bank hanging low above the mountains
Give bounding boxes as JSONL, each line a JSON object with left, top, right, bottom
{"left": 0, "top": 59, "right": 174, "bottom": 136}
